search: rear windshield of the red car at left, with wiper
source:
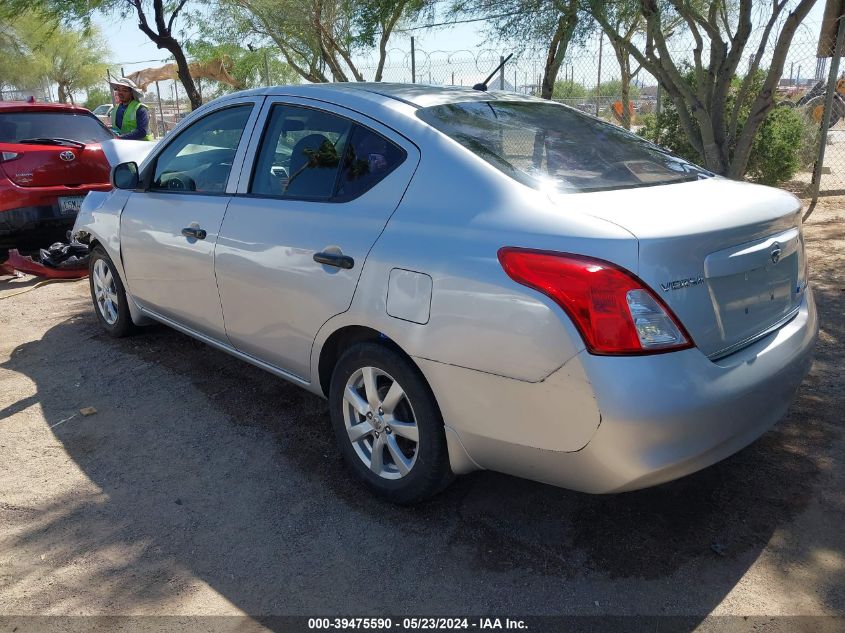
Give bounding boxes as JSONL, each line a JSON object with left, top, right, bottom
{"left": 0, "top": 112, "right": 114, "bottom": 143}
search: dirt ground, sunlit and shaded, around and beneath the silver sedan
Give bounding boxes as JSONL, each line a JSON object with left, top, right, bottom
{"left": 0, "top": 198, "right": 845, "bottom": 631}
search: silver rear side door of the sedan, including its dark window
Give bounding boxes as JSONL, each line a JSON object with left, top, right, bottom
{"left": 215, "top": 97, "right": 419, "bottom": 379}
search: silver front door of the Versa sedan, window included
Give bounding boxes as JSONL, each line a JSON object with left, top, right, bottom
{"left": 120, "top": 99, "right": 260, "bottom": 342}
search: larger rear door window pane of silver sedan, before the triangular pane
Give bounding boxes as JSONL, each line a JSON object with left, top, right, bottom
{"left": 250, "top": 105, "right": 352, "bottom": 200}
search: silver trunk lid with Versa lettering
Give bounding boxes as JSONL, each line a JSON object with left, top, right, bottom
{"left": 553, "top": 178, "right": 806, "bottom": 358}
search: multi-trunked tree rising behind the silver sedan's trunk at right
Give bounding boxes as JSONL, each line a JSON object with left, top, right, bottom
{"left": 592, "top": 0, "right": 815, "bottom": 178}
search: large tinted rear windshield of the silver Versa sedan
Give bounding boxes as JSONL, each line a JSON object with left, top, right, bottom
{"left": 417, "top": 101, "right": 710, "bottom": 192}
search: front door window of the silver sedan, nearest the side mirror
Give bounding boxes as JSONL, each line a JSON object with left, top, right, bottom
{"left": 150, "top": 104, "right": 253, "bottom": 193}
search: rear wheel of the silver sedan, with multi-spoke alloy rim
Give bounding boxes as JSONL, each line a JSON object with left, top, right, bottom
{"left": 329, "top": 343, "right": 452, "bottom": 504}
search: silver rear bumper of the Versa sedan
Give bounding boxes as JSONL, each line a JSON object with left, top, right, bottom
{"left": 421, "top": 289, "right": 818, "bottom": 493}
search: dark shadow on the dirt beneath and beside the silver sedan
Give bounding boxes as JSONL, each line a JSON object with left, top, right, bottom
{"left": 0, "top": 225, "right": 845, "bottom": 616}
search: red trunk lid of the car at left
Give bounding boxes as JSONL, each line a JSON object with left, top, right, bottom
{"left": 0, "top": 143, "right": 110, "bottom": 187}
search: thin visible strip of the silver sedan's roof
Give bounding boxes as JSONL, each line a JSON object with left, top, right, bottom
{"left": 231, "top": 81, "right": 542, "bottom": 108}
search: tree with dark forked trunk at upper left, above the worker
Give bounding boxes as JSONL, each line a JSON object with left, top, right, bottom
{"left": 0, "top": 0, "right": 202, "bottom": 109}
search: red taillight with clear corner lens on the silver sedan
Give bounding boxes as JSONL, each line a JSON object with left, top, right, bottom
{"left": 499, "top": 247, "right": 693, "bottom": 355}
